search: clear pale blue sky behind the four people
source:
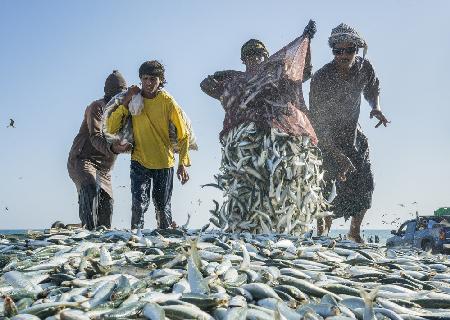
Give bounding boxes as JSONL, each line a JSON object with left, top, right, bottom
{"left": 0, "top": 0, "right": 450, "bottom": 229}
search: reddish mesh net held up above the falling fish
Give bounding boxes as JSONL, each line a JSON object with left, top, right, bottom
{"left": 220, "top": 37, "right": 317, "bottom": 144}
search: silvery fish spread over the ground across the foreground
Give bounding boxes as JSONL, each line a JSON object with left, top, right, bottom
{"left": 0, "top": 229, "right": 450, "bottom": 320}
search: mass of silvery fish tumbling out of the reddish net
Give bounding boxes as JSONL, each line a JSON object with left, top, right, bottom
{"left": 210, "top": 122, "right": 335, "bottom": 235}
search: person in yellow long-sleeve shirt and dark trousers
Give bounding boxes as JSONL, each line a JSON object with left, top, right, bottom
{"left": 107, "top": 60, "right": 191, "bottom": 229}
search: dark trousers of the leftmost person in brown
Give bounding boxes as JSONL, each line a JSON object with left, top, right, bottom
{"left": 78, "top": 184, "right": 113, "bottom": 230}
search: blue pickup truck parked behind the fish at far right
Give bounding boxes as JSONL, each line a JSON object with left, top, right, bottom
{"left": 386, "top": 216, "right": 450, "bottom": 253}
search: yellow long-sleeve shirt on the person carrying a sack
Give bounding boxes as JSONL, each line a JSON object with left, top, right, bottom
{"left": 106, "top": 91, "right": 191, "bottom": 169}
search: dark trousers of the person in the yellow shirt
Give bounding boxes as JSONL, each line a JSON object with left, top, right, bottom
{"left": 130, "top": 161, "right": 173, "bottom": 229}
